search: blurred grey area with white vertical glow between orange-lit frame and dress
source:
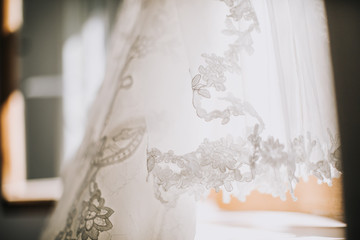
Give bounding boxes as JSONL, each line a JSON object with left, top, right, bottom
{"left": 13, "top": 0, "right": 119, "bottom": 179}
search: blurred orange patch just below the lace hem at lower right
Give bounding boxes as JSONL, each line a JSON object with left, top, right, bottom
{"left": 210, "top": 176, "right": 343, "bottom": 220}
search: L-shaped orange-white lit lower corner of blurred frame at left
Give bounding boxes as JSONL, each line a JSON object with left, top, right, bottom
{"left": 0, "top": 91, "right": 62, "bottom": 202}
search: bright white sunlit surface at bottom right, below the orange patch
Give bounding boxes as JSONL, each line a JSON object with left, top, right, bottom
{"left": 195, "top": 203, "right": 346, "bottom": 240}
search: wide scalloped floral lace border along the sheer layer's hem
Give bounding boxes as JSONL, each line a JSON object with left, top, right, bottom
{"left": 147, "top": 125, "right": 341, "bottom": 205}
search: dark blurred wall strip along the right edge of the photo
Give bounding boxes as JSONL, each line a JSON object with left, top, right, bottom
{"left": 326, "top": 0, "right": 360, "bottom": 239}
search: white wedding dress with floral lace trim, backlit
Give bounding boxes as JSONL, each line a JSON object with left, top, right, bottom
{"left": 43, "top": 0, "right": 341, "bottom": 240}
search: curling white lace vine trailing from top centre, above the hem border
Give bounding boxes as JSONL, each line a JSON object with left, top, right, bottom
{"left": 192, "top": 0, "right": 263, "bottom": 125}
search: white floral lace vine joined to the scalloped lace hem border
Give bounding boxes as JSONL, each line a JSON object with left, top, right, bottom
{"left": 147, "top": 0, "right": 341, "bottom": 204}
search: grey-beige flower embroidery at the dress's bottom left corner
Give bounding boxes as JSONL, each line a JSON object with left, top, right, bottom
{"left": 77, "top": 183, "right": 114, "bottom": 240}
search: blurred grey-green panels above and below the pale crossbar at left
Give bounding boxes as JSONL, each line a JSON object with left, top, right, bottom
{"left": 19, "top": 0, "right": 64, "bottom": 179}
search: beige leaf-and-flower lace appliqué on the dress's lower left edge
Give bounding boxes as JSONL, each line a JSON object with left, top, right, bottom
{"left": 55, "top": 125, "right": 145, "bottom": 240}
